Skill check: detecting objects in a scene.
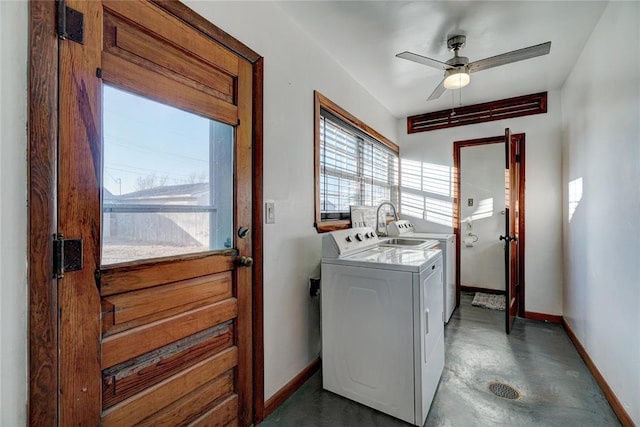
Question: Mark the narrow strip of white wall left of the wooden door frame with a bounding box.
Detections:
[0,1,27,426]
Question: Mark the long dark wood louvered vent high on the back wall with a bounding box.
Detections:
[407,92,547,133]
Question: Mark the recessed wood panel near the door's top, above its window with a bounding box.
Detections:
[104,14,235,103]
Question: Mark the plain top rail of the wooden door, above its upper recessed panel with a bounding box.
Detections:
[103,0,238,76]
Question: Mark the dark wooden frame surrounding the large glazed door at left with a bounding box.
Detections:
[27,0,264,426]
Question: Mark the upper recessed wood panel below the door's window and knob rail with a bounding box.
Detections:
[102,272,232,336]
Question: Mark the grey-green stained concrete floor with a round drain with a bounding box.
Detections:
[260,293,620,427]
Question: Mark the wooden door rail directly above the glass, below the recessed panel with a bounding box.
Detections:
[102,51,238,125]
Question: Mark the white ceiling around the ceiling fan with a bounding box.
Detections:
[278,0,607,118]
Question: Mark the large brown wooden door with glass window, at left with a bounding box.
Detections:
[57,0,253,425]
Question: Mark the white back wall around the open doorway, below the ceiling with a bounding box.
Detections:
[397,91,562,315]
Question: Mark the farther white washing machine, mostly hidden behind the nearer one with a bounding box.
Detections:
[387,219,457,323]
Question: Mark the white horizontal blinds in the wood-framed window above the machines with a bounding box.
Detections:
[319,109,398,220]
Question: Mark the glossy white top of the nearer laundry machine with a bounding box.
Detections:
[325,246,442,272]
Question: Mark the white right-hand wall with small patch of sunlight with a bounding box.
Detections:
[562,2,640,425]
